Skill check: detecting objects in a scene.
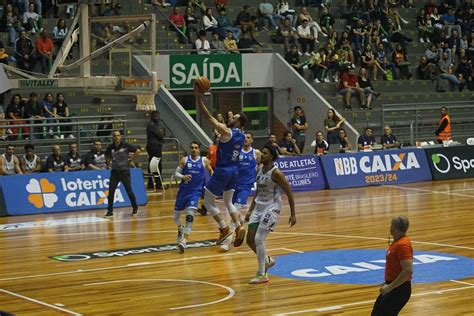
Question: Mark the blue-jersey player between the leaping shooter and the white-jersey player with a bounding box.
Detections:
[221,132,261,251]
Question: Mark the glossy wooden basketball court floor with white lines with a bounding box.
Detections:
[0,179,474,316]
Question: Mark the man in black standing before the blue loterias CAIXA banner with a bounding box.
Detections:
[104,131,140,218]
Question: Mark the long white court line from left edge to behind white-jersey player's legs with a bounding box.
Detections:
[0,248,282,281]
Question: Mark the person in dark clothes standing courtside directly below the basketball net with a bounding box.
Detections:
[146,111,166,189]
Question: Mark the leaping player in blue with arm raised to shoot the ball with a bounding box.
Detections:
[194,86,247,244]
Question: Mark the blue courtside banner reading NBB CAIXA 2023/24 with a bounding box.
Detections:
[321,148,431,189]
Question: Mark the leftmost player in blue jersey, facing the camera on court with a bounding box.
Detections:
[173,142,212,253]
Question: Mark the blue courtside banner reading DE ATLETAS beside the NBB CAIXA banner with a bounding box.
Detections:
[274,155,326,192]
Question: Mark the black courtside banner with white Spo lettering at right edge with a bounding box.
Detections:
[425,146,474,180]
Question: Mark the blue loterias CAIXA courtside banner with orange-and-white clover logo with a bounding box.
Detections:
[0,168,147,215]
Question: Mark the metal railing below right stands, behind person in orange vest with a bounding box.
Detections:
[382,101,474,144]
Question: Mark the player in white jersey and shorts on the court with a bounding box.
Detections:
[245,145,296,284]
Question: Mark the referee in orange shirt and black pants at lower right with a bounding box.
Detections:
[372,216,413,316]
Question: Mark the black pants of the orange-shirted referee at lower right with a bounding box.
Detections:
[372,281,411,316]
